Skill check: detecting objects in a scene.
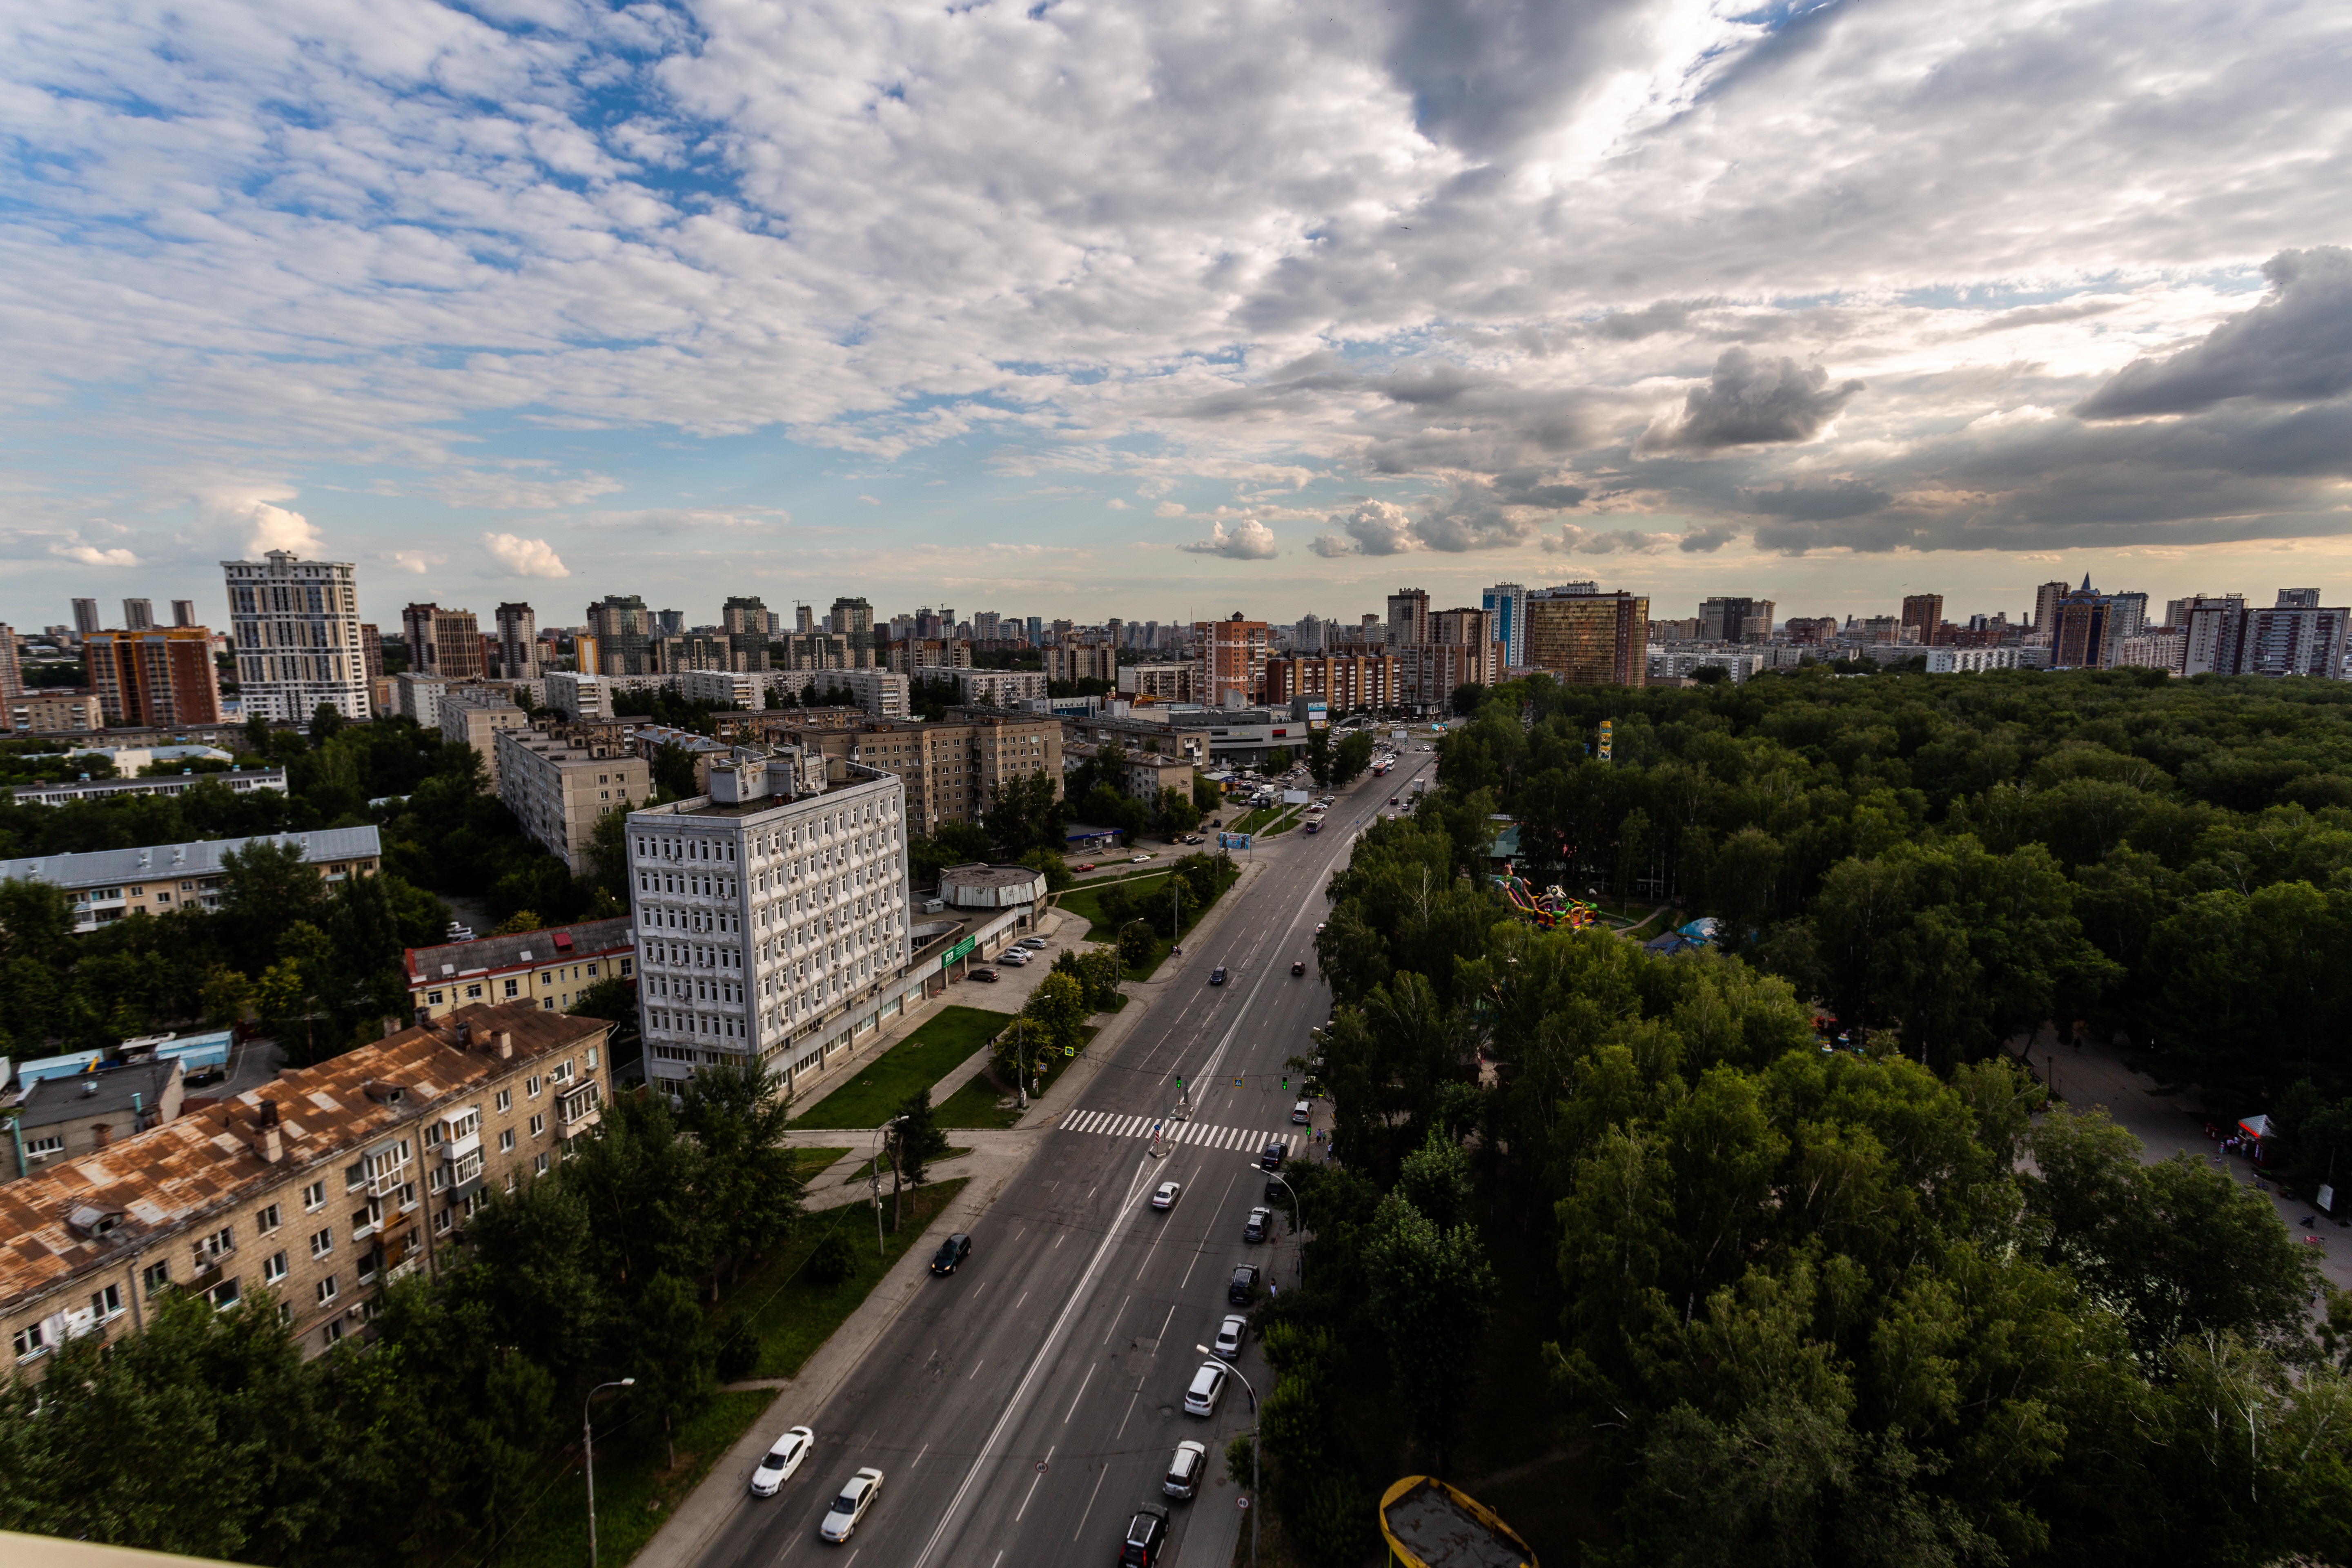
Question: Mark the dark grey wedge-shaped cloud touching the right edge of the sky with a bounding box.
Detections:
[2074,245,2352,419]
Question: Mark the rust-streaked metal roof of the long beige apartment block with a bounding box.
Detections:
[0,1002,612,1312]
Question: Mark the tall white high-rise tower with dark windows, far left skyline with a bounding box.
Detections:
[221,550,369,724]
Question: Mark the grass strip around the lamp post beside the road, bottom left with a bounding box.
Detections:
[492,1389,776,1568]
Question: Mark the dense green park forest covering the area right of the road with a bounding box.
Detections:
[1263,670,2352,1568]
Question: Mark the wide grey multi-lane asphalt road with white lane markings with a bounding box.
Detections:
[701,731,1435,1568]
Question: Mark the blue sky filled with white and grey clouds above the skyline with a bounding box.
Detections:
[0,0,2352,625]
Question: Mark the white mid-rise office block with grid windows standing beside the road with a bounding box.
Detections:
[628,748,922,1086]
